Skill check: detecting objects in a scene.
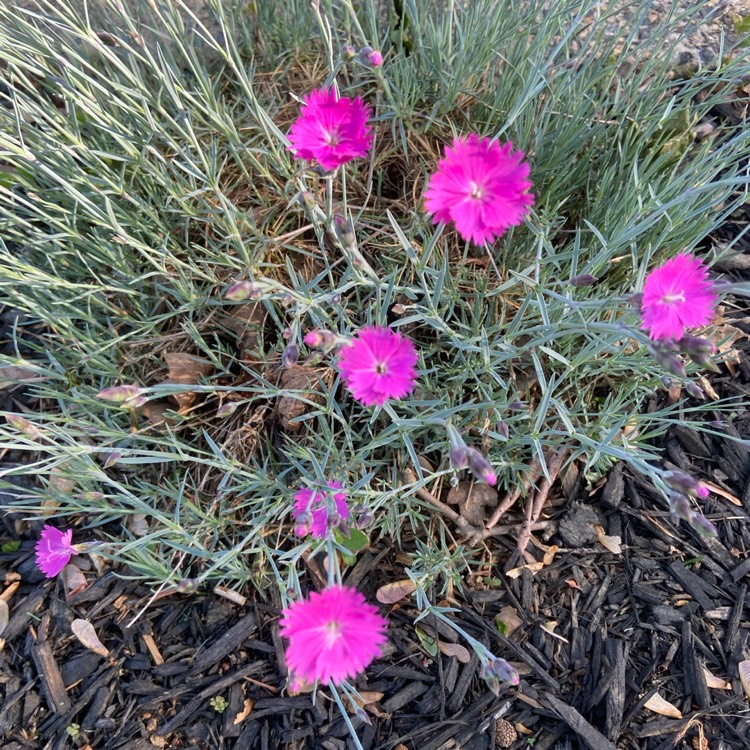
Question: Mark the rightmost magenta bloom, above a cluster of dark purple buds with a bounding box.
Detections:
[641,253,716,339]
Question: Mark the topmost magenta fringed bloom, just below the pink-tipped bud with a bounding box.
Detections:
[289,89,372,170]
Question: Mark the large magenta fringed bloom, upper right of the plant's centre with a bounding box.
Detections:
[425,134,534,245]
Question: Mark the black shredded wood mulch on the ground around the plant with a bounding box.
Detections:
[0,72,750,750]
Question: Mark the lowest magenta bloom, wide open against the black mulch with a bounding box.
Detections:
[280,586,387,685]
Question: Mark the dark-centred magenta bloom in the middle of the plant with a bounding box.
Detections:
[339,328,417,406]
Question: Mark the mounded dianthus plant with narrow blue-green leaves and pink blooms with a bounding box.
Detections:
[0,0,750,736]
